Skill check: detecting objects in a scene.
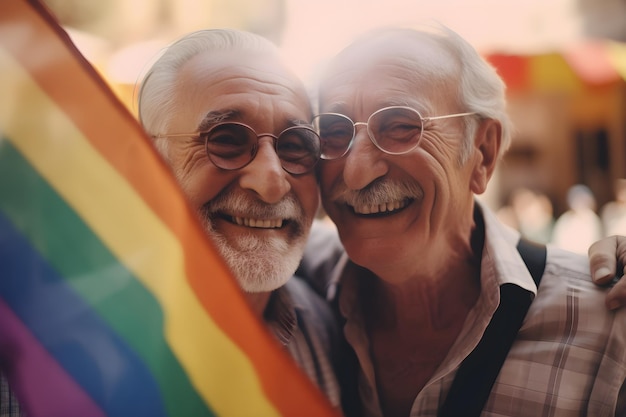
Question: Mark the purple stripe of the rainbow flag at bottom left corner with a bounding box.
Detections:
[0,298,105,417]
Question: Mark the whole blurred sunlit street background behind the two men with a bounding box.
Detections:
[44,0,626,251]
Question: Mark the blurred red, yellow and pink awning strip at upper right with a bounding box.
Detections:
[485,41,626,92]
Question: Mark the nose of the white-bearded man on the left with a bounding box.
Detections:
[239,137,291,204]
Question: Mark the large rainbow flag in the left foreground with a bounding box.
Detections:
[0,0,334,417]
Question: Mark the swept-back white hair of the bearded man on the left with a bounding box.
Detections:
[138,29,279,155]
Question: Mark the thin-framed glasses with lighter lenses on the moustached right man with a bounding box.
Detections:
[313,106,475,160]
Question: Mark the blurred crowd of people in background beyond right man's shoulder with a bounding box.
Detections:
[498,178,626,254]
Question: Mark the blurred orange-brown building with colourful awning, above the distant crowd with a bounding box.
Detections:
[487,46,626,215]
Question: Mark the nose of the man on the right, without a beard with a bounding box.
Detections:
[343,123,388,190]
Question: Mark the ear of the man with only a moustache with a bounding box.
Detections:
[470,119,502,194]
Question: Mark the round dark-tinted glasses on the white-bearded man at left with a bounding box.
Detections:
[155,122,321,175]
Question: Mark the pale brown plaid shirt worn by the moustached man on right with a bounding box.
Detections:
[334,203,626,417]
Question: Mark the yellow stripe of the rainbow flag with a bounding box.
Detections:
[0,44,279,416]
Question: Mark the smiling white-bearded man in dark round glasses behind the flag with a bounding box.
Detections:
[139,30,340,408]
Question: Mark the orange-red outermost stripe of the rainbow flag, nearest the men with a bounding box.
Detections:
[0,1,334,416]
